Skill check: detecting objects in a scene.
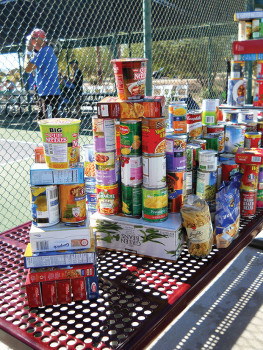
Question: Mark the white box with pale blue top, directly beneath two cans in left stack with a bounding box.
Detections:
[29,220,95,253]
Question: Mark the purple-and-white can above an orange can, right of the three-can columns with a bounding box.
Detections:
[166,134,187,171]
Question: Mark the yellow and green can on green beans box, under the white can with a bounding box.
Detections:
[142,187,168,222]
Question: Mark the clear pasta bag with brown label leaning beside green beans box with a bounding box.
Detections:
[181,195,213,258]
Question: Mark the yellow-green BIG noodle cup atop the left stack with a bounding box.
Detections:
[38,118,80,169]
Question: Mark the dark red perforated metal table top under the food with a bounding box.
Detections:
[0,210,263,350]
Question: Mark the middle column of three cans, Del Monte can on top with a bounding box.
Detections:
[120,120,142,216]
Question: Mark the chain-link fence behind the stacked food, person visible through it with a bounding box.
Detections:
[0,0,247,231]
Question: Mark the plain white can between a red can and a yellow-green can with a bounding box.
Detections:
[142,153,166,188]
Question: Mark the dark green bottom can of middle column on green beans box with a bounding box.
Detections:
[121,184,142,216]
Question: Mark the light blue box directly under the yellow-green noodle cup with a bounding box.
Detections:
[30,163,84,186]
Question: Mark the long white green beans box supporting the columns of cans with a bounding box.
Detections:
[90,213,184,261]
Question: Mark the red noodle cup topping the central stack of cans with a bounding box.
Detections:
[111,58,147,100]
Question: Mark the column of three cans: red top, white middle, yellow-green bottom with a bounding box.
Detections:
[142,118,168,222]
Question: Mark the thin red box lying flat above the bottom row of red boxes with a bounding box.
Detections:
[28,264,94,283]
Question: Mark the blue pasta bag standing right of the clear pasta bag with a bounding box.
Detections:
[215,173,242,248]
